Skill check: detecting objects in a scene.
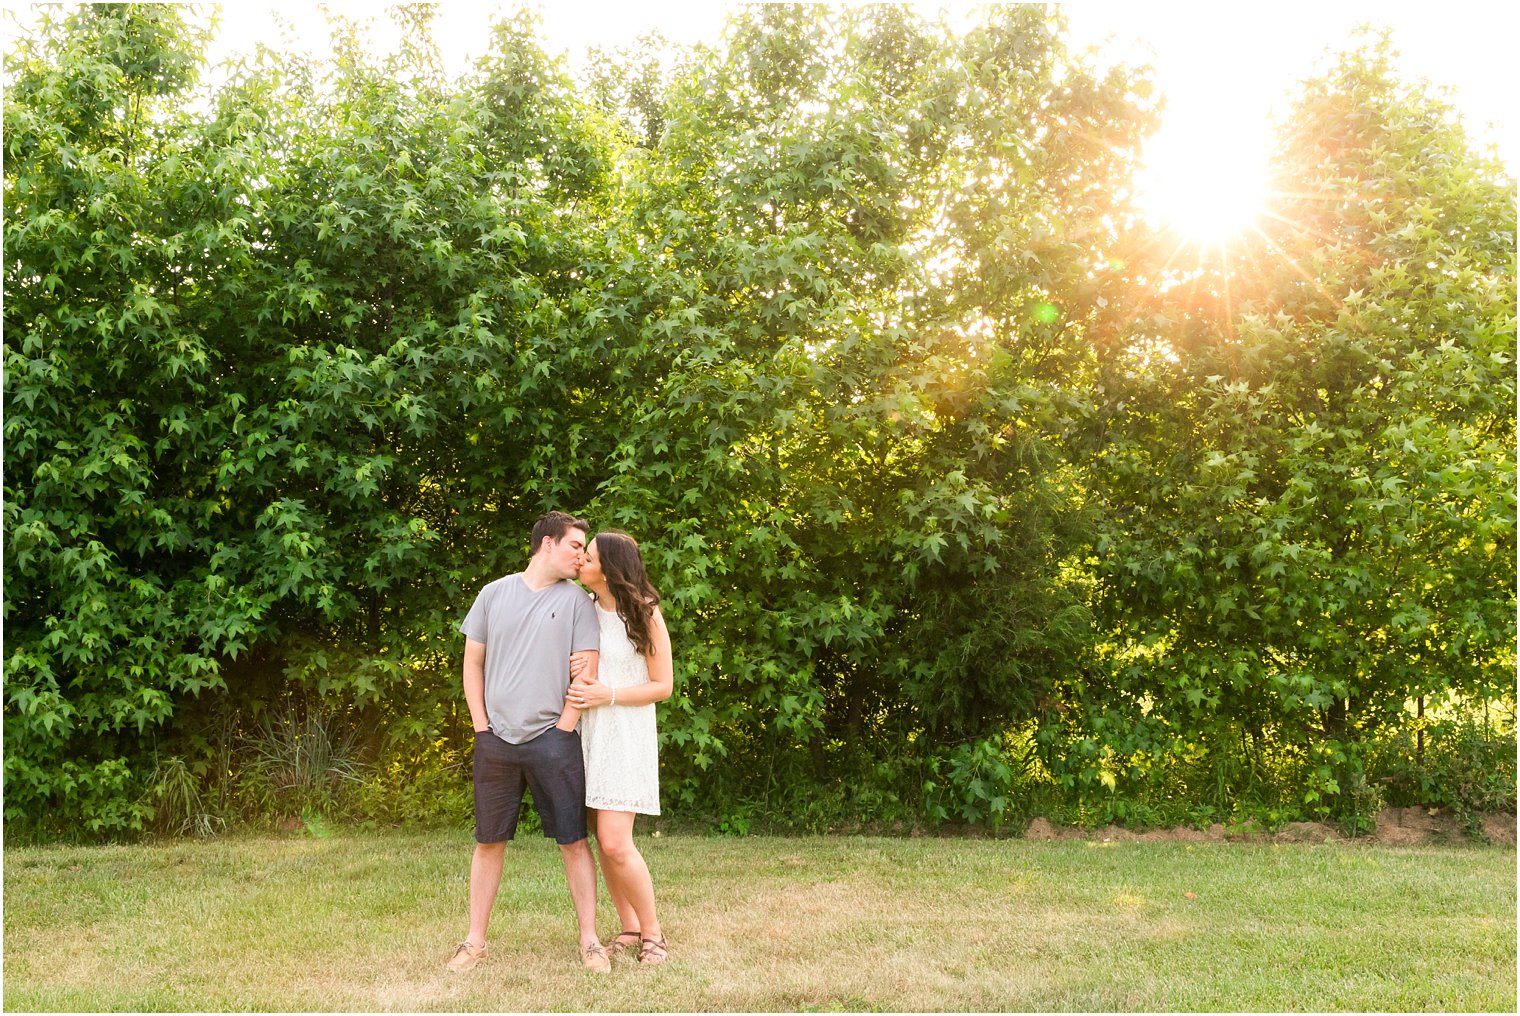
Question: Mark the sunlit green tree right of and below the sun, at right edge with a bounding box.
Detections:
[1096,40,1515,814]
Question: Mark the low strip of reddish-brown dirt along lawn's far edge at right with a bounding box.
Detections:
[1024,808,1515,847]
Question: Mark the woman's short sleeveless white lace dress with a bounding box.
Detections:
[581,605,660,815]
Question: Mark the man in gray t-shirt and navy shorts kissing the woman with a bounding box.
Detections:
[448,511,611,973]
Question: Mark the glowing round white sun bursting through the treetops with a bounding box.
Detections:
[1135,122,1266,246]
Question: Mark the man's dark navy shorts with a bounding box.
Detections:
[474,727,587,844]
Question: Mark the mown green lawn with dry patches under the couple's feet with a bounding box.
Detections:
[5,830,1515,1013]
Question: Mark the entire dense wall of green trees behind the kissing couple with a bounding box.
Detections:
[3,5,1515,837]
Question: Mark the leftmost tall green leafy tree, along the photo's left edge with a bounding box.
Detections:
[5,5,241,832]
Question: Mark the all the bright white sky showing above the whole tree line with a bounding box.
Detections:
[6,0,1520,238]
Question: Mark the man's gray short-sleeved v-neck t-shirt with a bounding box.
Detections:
[459,572,602,744]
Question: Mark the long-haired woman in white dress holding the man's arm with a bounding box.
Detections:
[567,531,673,966]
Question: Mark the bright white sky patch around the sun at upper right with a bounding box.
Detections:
[1064,0,1520,239]
